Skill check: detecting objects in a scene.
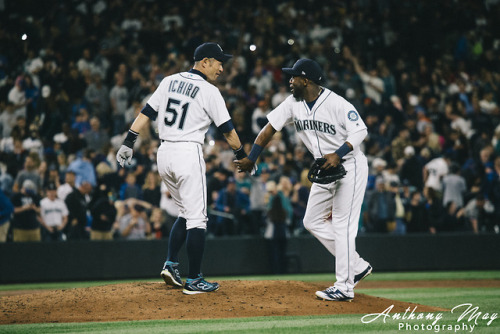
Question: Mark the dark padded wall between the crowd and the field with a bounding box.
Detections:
[0,234,500,283]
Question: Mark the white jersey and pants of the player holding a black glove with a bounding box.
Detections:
[267,88,369,297]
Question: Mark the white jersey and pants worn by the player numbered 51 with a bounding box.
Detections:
[148,72,231,230]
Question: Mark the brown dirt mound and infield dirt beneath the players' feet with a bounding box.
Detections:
[0,280,500,324]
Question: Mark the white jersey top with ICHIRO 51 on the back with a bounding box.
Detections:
[148,72,230,144]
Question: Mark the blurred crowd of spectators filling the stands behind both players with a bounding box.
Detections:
[0,0,500,242]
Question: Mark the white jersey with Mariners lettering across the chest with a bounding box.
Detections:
[267,88,366,159]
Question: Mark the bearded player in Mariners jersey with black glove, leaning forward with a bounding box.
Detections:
[236,59,372,301]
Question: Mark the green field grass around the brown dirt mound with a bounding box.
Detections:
[0,271,500,334]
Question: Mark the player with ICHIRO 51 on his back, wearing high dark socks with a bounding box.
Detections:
[116,43,250,294]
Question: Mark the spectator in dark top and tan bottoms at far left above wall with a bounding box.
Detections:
[12,179,42,242]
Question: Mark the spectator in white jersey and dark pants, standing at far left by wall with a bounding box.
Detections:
[40,183,68,241]
